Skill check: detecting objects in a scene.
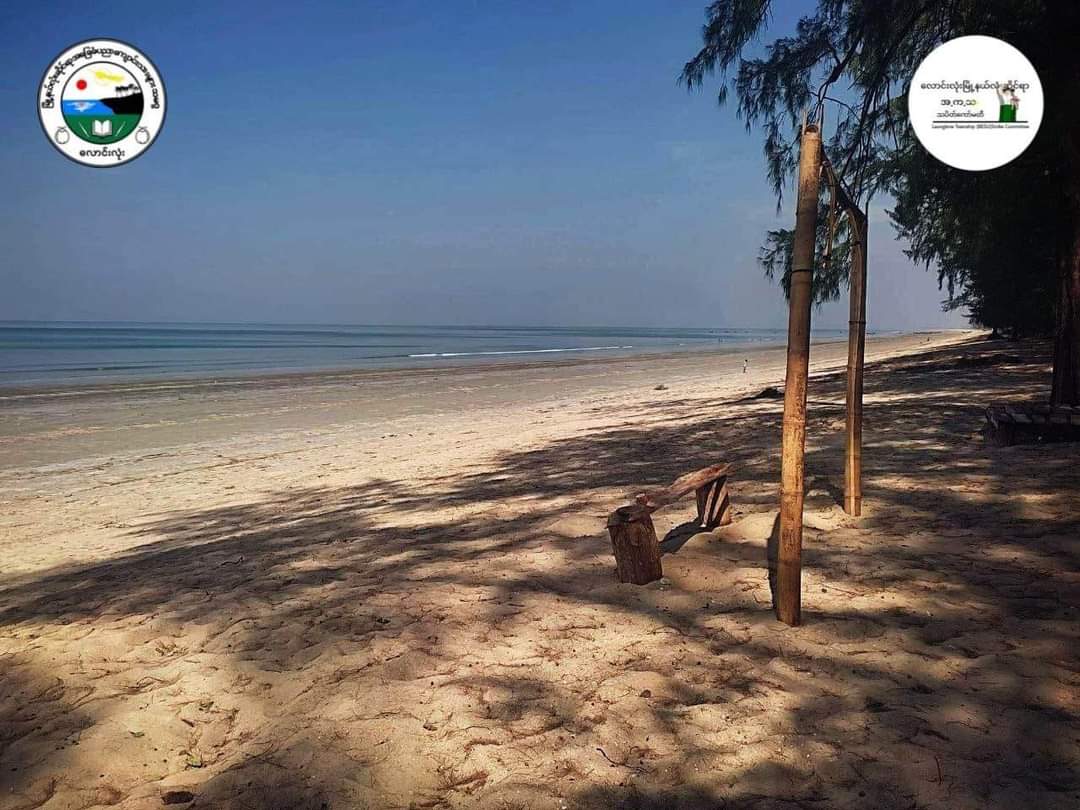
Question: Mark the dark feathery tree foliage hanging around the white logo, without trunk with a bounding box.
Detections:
[680,0,1080,332]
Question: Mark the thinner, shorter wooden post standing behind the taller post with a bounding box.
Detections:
[843,210,868,515]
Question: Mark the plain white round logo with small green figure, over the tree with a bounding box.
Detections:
[907,37,1042,172]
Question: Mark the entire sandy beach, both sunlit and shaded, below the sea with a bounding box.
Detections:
[0,333,1080,810]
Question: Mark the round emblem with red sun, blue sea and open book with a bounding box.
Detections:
[38,39,165,168]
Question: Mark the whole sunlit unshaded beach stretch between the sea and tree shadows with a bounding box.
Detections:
[0,332,978,567]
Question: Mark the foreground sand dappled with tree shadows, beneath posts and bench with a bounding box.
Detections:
[0,336,1080,810]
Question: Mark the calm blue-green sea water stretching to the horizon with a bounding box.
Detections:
[0,322,842,387]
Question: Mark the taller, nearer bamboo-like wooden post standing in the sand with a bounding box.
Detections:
[777,124,821,625]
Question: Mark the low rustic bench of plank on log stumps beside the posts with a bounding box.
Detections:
[607,464,731,585]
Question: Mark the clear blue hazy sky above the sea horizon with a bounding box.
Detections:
[0,0,963,329]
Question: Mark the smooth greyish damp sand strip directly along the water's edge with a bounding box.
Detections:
[0,333,977,475]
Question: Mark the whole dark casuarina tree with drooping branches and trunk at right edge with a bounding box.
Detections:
[680,0,1080,404]
